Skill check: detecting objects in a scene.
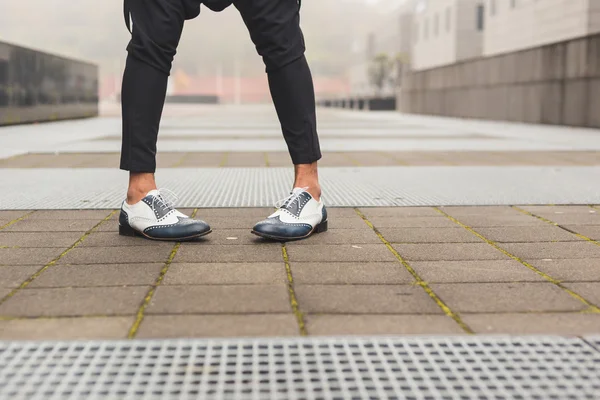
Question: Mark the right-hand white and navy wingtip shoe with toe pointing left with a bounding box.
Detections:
[252,188,327,242]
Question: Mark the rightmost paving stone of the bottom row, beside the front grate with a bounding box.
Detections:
[462,313,600,335]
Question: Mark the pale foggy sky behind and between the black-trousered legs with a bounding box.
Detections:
[0,0,398,75]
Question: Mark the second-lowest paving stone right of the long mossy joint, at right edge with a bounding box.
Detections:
[525,258,600,282]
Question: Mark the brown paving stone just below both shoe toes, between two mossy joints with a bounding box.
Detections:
[174,243,283,263]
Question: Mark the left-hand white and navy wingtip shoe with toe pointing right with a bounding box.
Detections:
[119,190,212,242]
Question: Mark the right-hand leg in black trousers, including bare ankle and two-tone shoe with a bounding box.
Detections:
[234,0,327,240]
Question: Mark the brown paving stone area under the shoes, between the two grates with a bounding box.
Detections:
[0,206,600,339]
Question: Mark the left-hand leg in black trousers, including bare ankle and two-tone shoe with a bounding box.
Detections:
[119,0,210,240]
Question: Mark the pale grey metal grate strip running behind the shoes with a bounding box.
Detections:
[0,167,600,210]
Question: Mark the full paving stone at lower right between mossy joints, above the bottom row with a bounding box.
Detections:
[430,282,587,313]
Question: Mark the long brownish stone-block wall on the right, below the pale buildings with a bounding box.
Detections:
[398,35,600,127]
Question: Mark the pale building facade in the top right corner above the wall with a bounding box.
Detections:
[483,0,600,56]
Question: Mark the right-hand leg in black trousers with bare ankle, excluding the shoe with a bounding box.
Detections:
[234,0,321,199]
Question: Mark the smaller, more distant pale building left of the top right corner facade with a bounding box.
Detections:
[411,0,486,71]
